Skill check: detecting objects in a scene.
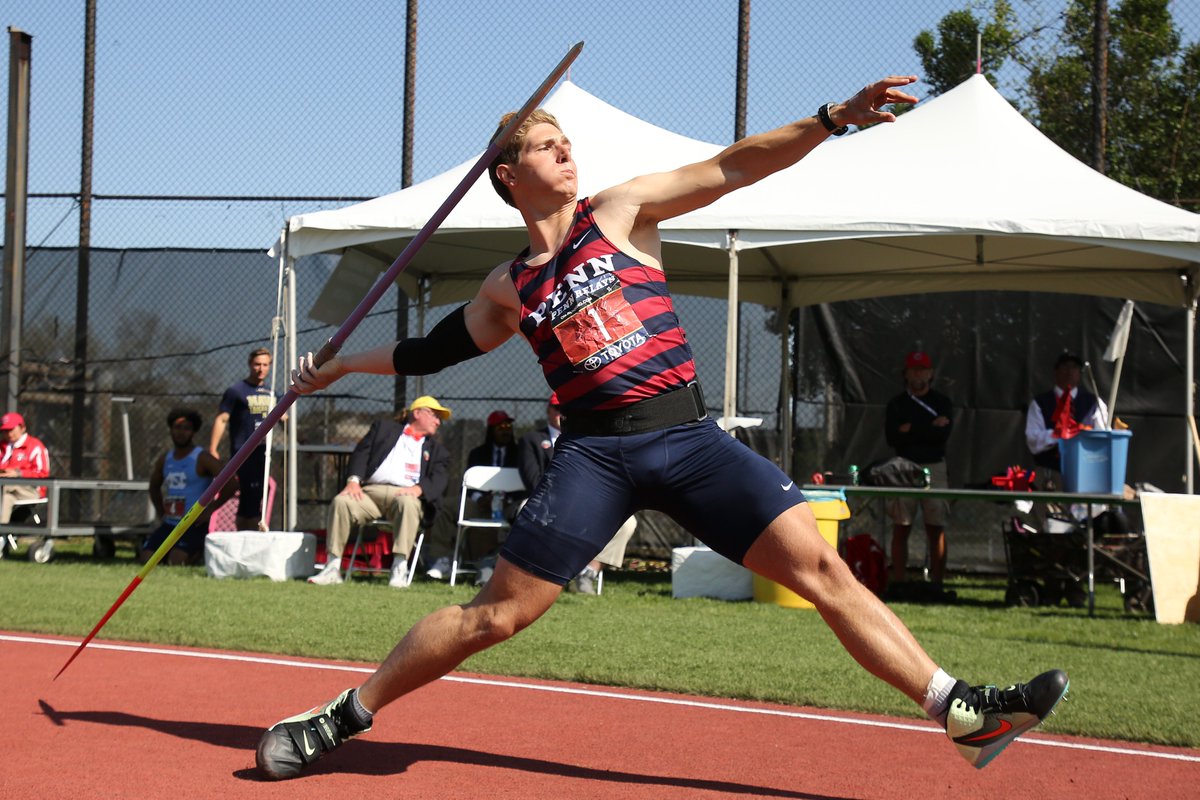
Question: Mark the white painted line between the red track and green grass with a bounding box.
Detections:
[7,633,1200,763]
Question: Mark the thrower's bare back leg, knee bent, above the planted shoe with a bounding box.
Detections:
[359,558,563,712]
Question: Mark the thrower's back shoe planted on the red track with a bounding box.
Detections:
[254,688,371,781]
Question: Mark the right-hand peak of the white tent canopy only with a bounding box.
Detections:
[668,74,1200,306]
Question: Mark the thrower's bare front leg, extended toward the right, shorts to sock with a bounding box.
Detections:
[743,504,937,705]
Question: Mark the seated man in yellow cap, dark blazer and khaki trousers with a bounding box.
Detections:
[308,395,450,589]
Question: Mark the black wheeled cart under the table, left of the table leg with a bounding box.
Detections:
[1002,517,1087,608]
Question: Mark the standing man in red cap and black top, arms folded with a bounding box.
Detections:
[883,350,953,600]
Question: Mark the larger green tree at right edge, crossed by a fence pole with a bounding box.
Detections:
[1028,0,1200,211]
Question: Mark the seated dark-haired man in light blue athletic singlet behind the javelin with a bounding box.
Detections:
[138,408,238,565]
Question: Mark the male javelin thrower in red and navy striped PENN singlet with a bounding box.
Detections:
[257,76,1068,778]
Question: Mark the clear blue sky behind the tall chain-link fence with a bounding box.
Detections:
[0,0,1200,247]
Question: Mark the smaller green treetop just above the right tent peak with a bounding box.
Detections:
[912,0,1018,95]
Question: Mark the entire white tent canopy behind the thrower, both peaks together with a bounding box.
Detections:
[278,74,1200,314]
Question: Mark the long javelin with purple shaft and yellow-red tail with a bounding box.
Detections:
[54,42,583,680]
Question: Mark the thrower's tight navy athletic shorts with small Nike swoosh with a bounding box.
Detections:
[500,419,804,585]
